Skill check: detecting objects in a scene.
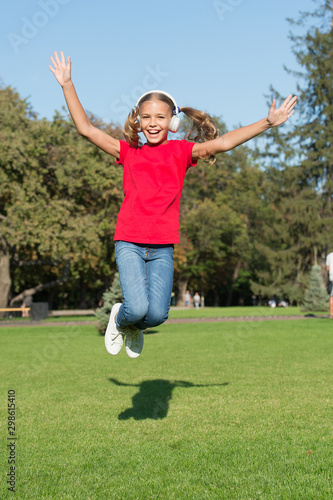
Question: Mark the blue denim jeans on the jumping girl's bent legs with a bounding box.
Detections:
[115,241,174,330]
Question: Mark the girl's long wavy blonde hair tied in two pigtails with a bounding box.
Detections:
[123,92,220,165]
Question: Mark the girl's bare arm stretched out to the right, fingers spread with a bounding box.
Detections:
[192,95,297,159]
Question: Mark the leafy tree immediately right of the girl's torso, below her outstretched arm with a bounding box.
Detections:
[174,118,263,305]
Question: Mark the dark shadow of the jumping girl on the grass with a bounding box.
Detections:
[109,378,229,420]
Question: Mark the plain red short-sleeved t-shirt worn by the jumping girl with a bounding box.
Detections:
[114,140,196,244]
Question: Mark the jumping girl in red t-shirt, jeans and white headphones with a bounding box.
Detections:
[49,52,297,358]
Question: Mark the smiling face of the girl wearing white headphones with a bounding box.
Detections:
[140,100,172,146]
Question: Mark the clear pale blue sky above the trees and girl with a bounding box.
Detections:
[0,0,315,129]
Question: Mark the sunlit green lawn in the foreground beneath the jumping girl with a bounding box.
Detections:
[0,318,333,500]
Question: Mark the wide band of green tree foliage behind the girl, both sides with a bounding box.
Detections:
[0,0,333,308]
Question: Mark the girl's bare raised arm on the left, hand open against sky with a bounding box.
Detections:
[49,52,120,158]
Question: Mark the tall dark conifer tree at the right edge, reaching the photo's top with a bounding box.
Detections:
[253,0,333,303]
